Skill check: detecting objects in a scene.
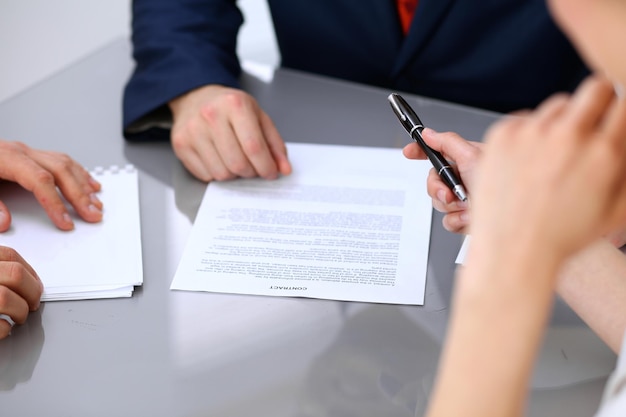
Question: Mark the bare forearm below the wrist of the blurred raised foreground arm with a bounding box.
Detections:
[428,245,557,417]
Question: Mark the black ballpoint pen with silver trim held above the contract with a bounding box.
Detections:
[387,93,467,201]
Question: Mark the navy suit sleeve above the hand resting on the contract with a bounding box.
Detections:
[123,0,243,140]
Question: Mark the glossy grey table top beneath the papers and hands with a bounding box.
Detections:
[0,40,615,417]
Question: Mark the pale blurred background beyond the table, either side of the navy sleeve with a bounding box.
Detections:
[0,0,279,102]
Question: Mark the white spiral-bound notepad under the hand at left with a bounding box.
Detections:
[0,165,143,301]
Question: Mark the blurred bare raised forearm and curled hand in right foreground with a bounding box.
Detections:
[428,78,626,417]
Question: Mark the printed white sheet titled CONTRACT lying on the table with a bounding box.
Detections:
[171,143,432,304]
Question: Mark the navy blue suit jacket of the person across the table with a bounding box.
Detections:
[123,0,588,139]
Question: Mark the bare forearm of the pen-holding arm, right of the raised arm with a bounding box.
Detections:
[557,240,626,353]
